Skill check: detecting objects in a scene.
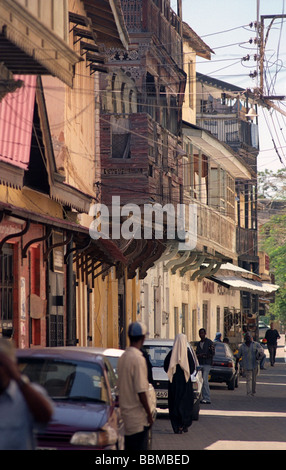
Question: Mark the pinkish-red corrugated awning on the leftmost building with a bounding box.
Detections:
[0,75,37,170]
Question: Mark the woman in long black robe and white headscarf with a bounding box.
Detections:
[164,334,196,434]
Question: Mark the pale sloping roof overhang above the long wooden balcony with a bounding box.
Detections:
[183,122,251,179]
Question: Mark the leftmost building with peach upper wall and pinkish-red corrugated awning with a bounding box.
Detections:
[0,0,128,347]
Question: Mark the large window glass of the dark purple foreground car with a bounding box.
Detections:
[19,358,109,403]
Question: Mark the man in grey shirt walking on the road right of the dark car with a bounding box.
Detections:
[236,332,264,396]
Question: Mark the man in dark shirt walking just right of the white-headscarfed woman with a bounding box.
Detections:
[196,328,215,404]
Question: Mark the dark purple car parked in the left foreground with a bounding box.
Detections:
[17,347,124,450]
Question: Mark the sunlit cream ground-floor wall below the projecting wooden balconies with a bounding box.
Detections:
[141,262,240,342]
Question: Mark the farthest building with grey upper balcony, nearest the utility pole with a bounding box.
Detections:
[194,73,275,340]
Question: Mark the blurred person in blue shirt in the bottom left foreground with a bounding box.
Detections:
[0,337,53,450]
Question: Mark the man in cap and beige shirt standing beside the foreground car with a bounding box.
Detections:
[118,322,153,451]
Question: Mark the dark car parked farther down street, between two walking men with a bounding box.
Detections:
[209,343,240,390]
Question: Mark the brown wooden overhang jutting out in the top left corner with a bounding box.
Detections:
[0,0,82,86]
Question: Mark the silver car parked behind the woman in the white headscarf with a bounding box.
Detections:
[143,339,203,421]
